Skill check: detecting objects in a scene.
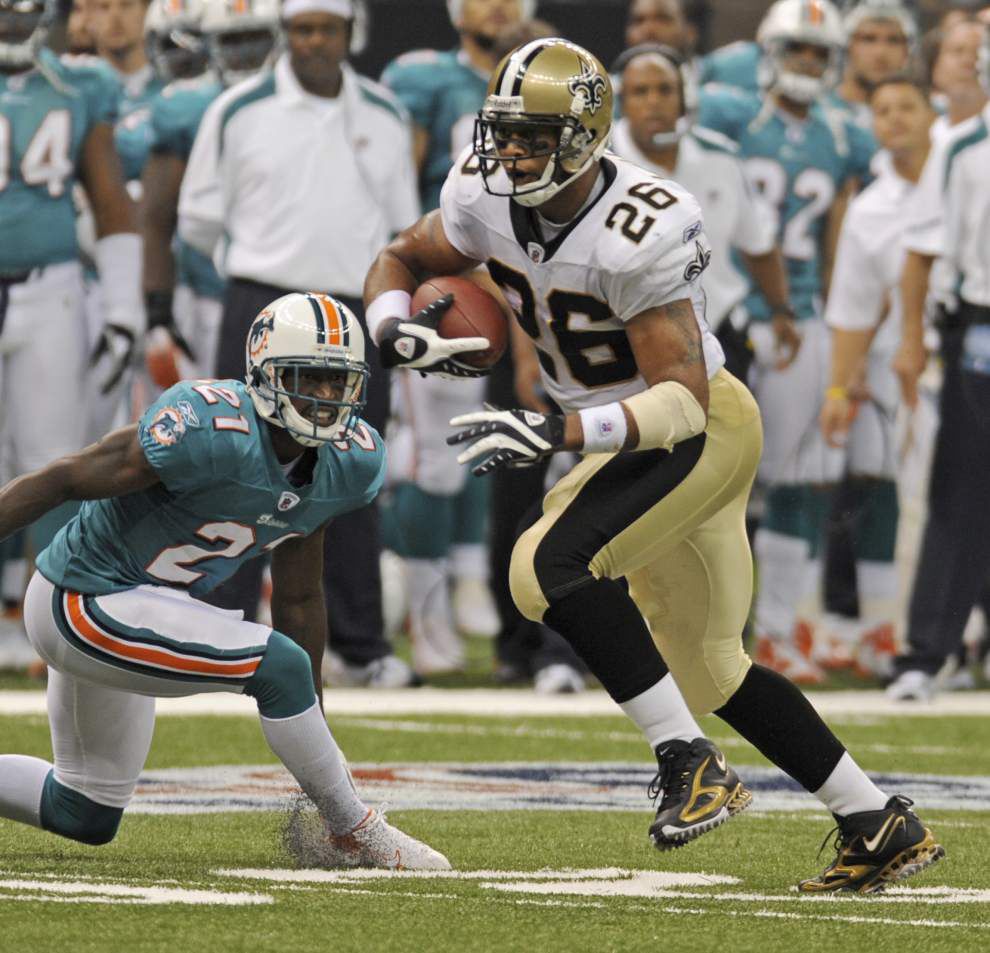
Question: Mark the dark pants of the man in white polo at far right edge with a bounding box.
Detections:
[897,303,990,675]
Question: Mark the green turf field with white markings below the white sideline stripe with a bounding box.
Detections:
[0,696,990,953]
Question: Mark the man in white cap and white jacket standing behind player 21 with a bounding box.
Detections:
[179,0,419,686]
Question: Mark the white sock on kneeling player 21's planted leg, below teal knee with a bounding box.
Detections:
[261,702,368,834]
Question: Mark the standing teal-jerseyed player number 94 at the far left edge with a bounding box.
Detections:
[0,0,143,665]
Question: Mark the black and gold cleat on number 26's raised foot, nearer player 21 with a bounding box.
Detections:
[648,738,753,850]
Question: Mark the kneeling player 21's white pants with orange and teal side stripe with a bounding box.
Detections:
[24,573,272,808]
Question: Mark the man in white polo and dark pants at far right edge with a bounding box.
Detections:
[891,27,990,697]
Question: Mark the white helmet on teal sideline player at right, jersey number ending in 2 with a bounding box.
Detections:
[756,0,845,103]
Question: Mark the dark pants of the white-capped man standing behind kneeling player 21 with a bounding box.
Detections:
[206,278,391,665]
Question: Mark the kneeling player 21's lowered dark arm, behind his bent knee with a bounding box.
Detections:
[272,528,327,704]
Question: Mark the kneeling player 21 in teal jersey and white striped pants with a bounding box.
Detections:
[0,294,450,869]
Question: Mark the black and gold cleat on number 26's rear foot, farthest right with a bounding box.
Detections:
[798,794,945,893]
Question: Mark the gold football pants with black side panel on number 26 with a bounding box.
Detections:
[509,370,762,714]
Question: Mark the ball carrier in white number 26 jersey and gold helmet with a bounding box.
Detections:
[365,39,941,892]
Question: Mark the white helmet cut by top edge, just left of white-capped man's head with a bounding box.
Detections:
[202,0,282,86]
